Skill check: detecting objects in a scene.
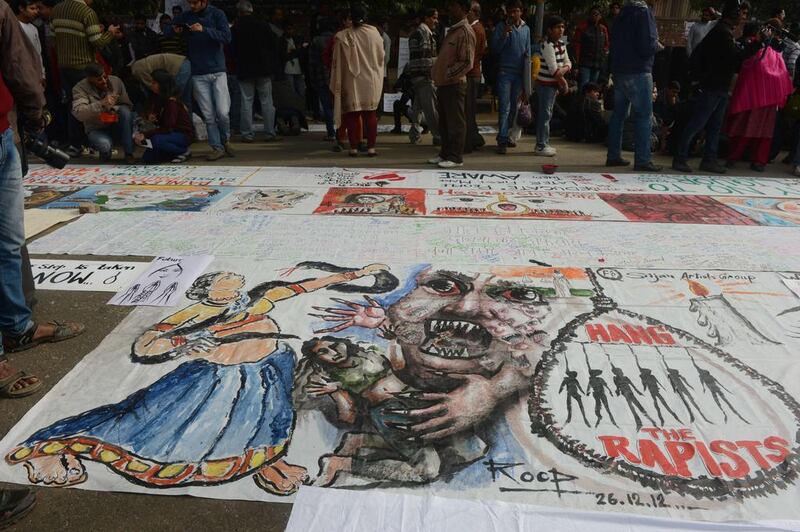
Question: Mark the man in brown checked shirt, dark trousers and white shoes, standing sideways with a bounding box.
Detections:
[428,0,475,168]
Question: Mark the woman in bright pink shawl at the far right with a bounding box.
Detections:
[725,28,794,172]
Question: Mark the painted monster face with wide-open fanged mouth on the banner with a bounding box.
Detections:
[389,268,591,375]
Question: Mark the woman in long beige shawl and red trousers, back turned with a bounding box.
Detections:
[330,4,385,157]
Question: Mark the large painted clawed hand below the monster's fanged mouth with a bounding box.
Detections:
[387,375,498,441]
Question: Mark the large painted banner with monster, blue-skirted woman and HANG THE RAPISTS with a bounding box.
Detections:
[0,260,800,521]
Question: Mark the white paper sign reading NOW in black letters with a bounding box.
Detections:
[31,259,148,292]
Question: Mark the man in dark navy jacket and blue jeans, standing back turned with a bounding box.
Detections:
[606,0,661,172]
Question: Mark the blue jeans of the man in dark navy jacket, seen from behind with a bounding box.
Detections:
[608,74,653,166]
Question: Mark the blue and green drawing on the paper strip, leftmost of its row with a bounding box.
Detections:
[44,185,231,212]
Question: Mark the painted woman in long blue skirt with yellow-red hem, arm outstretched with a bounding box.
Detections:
[6,264,388,495]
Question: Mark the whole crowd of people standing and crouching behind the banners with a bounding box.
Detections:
[3,0,800,171]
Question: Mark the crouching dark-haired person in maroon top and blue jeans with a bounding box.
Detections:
[133,69,194,164]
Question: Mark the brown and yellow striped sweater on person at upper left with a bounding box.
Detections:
[53,0,113,69]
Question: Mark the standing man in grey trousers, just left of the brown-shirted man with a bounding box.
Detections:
[405,8,442,146]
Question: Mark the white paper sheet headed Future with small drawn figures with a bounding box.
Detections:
[108,255,214,307]
